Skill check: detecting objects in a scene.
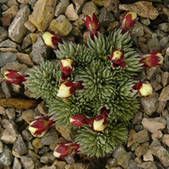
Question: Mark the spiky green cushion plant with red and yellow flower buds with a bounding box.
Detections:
[25,12,162,158]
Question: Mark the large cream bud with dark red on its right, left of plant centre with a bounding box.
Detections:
[57,81,76,98]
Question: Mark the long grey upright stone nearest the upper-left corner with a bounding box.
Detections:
[8,5,30,43]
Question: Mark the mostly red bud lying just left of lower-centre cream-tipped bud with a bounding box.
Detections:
[70,114,88,127]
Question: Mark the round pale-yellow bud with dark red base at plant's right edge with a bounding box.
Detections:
[136,82,153,96]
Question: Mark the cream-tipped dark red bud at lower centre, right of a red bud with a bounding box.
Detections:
[92,112,108,131]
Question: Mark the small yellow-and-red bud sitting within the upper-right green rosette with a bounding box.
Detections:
[110,49,126,67]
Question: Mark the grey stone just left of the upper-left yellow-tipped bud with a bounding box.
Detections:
[31,37,47,64]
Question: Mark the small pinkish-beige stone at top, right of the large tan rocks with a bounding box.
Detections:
[65,4,79,21]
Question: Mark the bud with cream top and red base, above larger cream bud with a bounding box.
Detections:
[60,59,73,76]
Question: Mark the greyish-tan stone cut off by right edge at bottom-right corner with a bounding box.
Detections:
[151,146,169,167]
